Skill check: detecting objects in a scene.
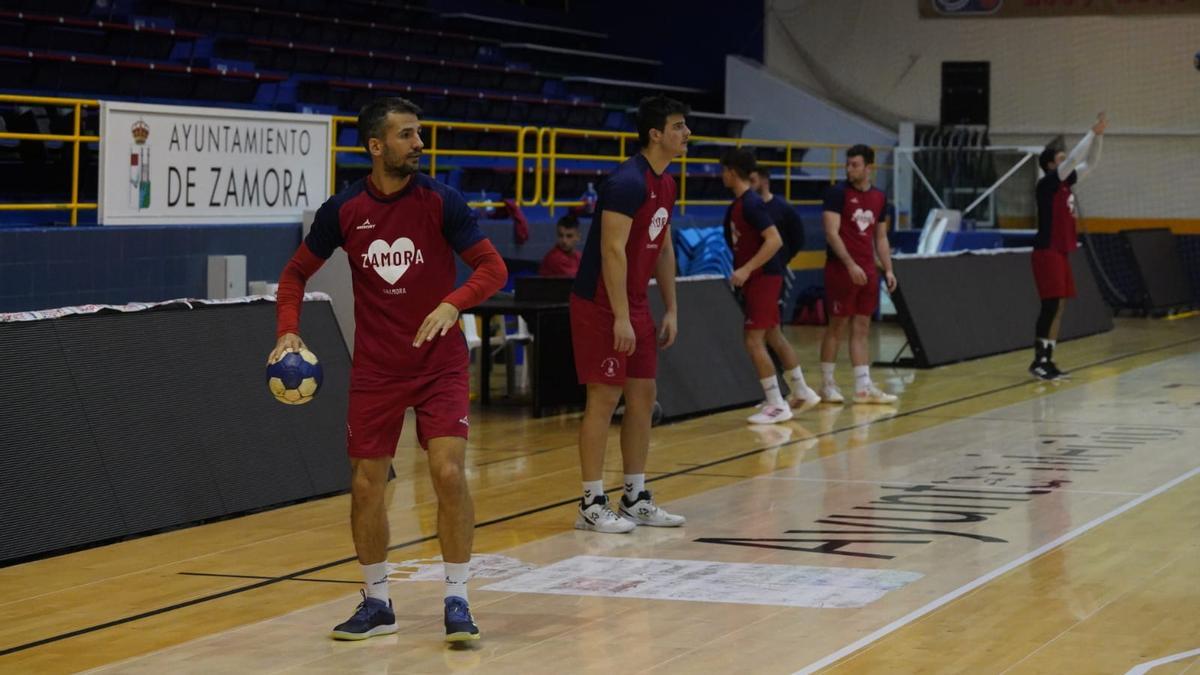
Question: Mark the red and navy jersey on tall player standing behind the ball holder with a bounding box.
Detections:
[574,153,676,311]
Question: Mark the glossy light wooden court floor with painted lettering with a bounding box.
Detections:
[0,318,1200,675]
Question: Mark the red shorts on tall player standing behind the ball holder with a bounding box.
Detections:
[571,293,659,386]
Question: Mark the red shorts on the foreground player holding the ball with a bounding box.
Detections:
[346,365,470,458]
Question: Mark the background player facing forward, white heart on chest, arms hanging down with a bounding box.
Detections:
[821,144,896,404]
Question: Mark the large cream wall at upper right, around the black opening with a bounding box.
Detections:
[764,0,1200,219]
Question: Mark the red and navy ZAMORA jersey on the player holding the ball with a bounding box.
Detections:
[305,174,484,376]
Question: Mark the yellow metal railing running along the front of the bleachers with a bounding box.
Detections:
[0,95,892,225]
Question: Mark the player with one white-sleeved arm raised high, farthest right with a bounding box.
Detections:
[1030,113,1109,380]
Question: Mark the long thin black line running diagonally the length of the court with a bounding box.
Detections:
[0,338,1200,656]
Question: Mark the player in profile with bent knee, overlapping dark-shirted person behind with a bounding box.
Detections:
[721,148,817,424]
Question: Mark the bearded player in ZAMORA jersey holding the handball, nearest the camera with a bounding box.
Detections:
[270,98,508,641]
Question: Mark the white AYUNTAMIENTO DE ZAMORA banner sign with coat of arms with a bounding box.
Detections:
[100,101,331,225]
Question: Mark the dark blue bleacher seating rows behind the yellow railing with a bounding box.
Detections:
[0,0,748,225]
